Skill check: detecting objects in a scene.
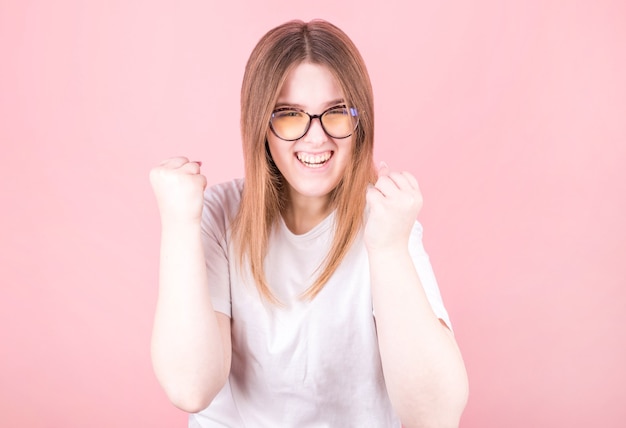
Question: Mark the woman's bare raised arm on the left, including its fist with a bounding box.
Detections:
[150,158,231,412]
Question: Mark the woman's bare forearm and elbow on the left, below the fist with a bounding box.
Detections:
[152,224,230,412]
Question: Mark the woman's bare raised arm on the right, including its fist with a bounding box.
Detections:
[365,162,468,428]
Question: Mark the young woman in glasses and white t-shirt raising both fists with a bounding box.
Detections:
[151,20,467,428]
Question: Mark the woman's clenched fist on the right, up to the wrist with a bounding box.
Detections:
[365,162,423,251]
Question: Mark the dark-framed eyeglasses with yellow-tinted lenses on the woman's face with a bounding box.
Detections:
[270,106,359,141]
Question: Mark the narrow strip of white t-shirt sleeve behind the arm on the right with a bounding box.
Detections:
[409,221,452,329]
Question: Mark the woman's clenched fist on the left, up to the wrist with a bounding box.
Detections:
[150,157,207,224]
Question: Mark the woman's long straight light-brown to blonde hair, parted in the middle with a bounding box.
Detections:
[233,20,376,304]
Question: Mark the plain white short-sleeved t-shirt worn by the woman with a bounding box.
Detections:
[189,180,450,428]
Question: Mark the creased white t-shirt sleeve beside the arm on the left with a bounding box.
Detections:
[202,181,236,317]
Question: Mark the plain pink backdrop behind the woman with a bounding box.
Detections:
[0,0,626,428]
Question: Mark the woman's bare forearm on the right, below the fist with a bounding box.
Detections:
[369,248,468,428]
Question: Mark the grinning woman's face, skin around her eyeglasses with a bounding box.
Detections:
[267,63,354,209]
